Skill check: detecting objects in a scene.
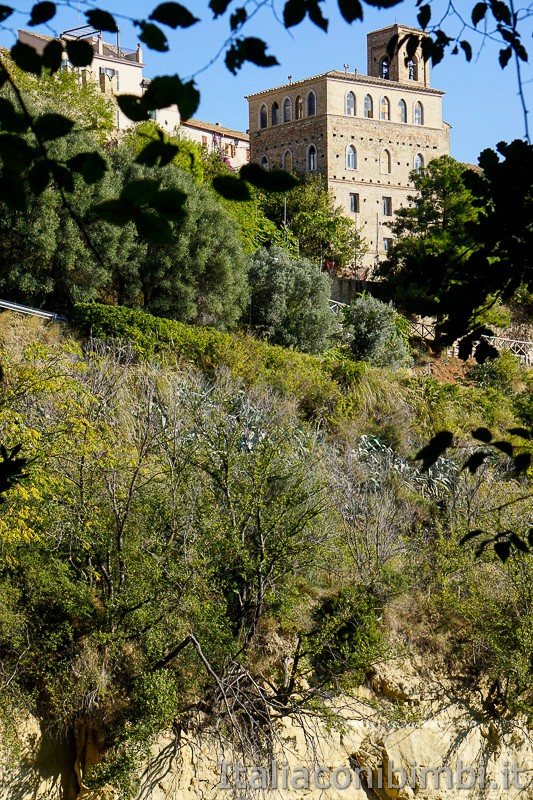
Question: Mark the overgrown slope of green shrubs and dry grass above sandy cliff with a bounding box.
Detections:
[0,305,533,797]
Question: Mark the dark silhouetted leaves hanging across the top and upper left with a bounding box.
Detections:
[0,0,527,276]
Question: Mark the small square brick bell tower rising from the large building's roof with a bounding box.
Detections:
[366,25,430,88]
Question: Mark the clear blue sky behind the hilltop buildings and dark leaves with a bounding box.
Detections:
[0,0,533,163]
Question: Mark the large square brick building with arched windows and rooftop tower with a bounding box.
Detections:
[247,25,450,278]
